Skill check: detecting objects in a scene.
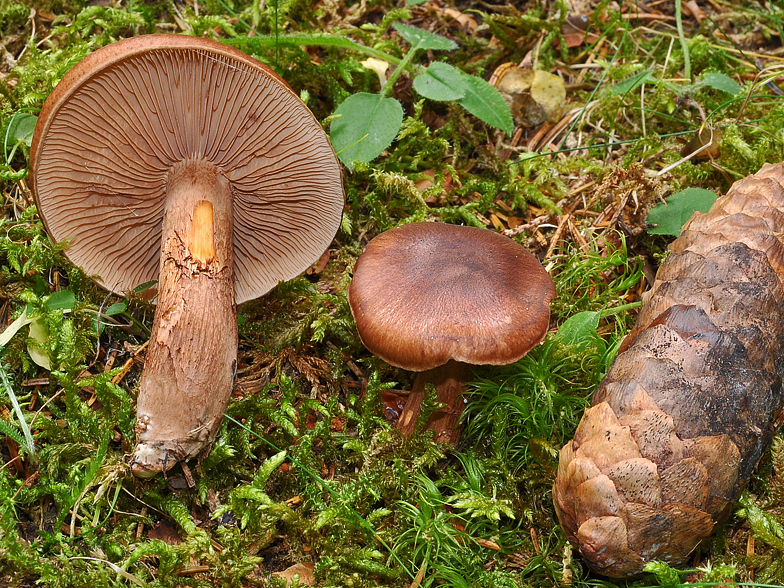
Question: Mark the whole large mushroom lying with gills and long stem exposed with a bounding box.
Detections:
[30,35,343,477]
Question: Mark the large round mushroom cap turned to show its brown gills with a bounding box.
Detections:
[30,35,343,303]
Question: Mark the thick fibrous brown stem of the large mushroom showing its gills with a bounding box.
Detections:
[132,160,238,477]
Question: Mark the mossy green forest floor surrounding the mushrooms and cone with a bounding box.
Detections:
[0,0,784,588]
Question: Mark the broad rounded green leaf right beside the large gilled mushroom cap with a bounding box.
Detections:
[329,92,403,169]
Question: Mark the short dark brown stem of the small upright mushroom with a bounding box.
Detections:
[397,359,473,445]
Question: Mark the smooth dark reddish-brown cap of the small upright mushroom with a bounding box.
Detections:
[348,223,555,371]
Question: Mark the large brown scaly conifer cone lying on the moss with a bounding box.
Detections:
[553,164,784,577]
